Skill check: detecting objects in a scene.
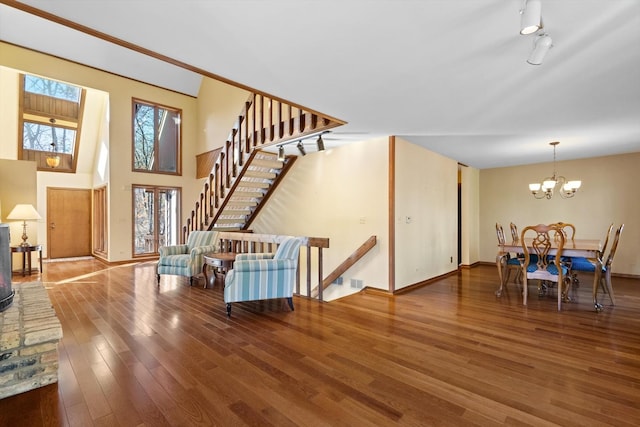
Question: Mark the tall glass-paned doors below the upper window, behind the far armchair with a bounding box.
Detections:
[132,185,180,256]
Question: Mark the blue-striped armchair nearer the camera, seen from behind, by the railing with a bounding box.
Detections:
[224,237,302,316]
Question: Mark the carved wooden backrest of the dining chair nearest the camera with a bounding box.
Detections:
[520,224,565,271]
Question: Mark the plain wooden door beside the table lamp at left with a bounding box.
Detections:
[47,187,91,259]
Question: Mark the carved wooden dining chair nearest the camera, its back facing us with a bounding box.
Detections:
[520,224,568,311]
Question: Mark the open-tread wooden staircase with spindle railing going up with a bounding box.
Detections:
[182,93,345,242]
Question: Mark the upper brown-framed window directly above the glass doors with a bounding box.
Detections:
[133,99,182,175]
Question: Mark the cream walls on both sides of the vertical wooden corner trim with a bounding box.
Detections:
[251,138,457,300]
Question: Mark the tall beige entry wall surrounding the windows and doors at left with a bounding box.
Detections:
[0,43,201,261]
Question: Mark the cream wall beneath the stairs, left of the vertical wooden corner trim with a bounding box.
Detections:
[251,138,389,299]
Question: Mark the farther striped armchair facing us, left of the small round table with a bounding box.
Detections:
[156,231,218,285]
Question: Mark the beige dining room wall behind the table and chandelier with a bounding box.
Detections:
[480,153,640,275]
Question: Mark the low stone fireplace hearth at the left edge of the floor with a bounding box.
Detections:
[0,282,62,399]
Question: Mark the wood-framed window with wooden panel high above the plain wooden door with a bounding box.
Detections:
[18,74,84,172]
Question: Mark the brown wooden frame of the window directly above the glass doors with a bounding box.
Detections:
[131,98,182,176]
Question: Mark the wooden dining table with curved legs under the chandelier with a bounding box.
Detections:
[496,238,602,311]
